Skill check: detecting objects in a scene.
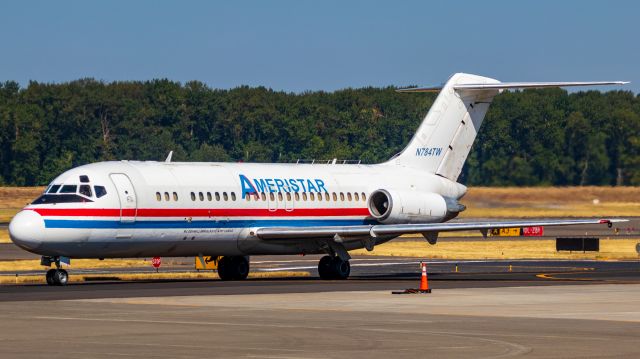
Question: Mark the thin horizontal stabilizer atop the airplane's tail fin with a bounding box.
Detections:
[396,81,629,92]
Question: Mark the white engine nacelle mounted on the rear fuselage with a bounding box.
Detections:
[367,189,465,224]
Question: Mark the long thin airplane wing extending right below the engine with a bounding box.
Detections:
[255,219,628,240]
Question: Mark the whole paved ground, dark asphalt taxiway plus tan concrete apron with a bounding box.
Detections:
[0,256,640,358]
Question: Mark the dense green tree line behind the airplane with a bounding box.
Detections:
[0,79,640,186]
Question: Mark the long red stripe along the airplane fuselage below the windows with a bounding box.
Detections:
[32,208,369,217]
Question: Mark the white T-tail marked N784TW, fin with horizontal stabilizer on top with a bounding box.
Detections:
[388,73,628,181]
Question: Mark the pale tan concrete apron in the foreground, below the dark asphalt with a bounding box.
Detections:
[0,284,640,358]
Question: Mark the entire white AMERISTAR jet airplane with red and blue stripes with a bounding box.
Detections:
[9,73,626,285]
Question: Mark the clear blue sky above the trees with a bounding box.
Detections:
[0,0,640,93]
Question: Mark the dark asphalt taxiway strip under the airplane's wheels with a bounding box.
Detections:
[0,256,640,302]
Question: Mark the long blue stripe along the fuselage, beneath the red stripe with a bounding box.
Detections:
[44,219,374,229]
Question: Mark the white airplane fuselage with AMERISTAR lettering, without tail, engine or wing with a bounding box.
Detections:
[12,161,466,258]
